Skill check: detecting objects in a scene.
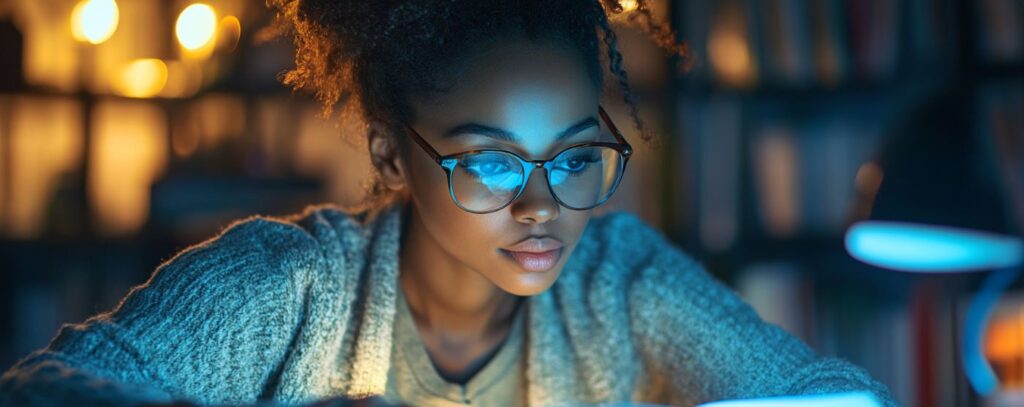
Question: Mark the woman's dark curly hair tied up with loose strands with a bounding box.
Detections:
[266,0,687,210]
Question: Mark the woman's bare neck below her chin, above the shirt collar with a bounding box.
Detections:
[398,205,519,340]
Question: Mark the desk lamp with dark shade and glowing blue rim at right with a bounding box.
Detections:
[845,90,1024,396]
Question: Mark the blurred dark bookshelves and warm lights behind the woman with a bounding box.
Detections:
[0,0,1024,406]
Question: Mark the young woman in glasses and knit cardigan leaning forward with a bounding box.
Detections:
[0,0,895,405]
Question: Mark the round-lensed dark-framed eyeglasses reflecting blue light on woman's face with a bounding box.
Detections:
[406,106,633,213]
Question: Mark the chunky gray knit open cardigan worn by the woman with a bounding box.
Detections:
[0,205,896,406]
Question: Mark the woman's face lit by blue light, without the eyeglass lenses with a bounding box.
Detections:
[393,41,611,295]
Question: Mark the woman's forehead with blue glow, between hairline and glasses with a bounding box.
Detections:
[413,40,599,154]
